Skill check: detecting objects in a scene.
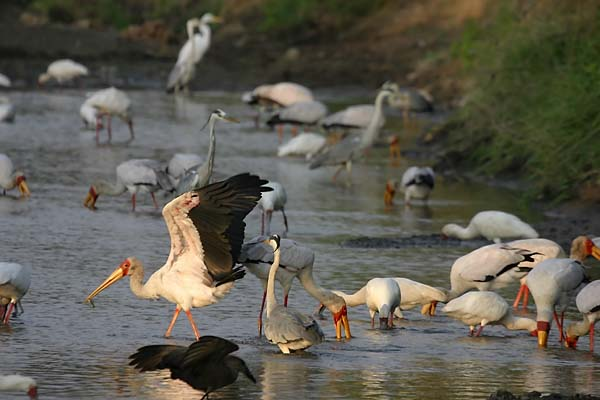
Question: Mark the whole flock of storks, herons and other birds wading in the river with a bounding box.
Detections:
[0,14,600,398]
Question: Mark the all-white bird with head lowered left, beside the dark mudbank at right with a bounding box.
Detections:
[442,211,539,243]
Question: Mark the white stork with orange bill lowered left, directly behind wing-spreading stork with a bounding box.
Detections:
[83,158,173,211]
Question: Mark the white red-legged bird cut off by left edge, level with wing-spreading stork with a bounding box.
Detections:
[0,262,31,324]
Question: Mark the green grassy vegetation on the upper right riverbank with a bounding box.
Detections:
[448,2,600,201]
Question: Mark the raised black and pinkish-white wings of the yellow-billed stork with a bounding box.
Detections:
[163,173,271,278]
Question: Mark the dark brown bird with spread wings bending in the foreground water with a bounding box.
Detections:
[129,336,256,399]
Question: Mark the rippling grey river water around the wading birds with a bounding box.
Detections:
[0,90,600,400]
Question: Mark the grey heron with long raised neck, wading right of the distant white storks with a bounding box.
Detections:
[309,87,395,182]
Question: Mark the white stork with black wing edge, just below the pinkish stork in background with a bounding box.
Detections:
[267,100,327,143]
